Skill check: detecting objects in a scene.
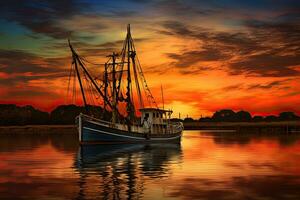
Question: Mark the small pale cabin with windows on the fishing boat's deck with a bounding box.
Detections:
[140,108,172,134]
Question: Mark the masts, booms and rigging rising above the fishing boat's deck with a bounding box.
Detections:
[69,24,159,124]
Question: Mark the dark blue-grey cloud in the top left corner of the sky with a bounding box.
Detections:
[0,0,88,39]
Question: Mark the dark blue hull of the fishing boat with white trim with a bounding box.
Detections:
[78,116,182,143]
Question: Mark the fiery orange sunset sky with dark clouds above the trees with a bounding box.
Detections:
[0,0,300,118]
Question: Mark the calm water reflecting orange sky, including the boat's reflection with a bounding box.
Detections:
[0,131,300,200]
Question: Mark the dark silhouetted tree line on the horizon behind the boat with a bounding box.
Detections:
[0,104,300,126]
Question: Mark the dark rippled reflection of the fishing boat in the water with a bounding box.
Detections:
[75,144,182,199]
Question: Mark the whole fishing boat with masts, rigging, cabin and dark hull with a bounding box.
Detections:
[69,25,183,143]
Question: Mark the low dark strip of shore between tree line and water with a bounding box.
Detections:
[0,121,300,134]
